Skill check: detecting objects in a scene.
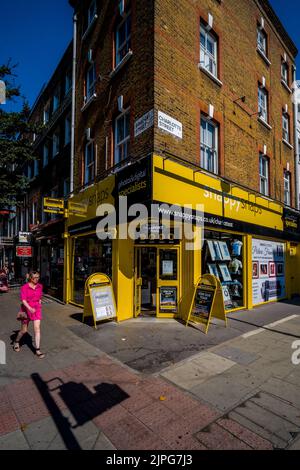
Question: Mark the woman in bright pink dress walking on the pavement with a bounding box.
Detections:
[13,271,45,359]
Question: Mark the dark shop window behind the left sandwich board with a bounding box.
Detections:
[72,239,112,305]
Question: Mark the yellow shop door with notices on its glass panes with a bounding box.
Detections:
[156,247,180,317]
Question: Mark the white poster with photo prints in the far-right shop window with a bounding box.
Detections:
[252,239,286,305]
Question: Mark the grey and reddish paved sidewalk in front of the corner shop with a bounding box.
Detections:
[0,291,300,451]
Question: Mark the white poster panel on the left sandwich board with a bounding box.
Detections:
[90,286,117,321]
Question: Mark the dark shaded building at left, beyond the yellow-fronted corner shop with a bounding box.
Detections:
[10,43,73,299]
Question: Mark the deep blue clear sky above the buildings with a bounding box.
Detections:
[0,0,300,110]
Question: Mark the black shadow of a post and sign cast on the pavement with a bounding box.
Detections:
[31,374,129,450]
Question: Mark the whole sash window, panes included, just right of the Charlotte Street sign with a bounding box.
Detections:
[201,118,218,174]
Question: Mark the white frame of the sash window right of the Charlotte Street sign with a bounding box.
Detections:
[200,116,219,175]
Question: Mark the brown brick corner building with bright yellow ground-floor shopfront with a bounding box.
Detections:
[65,0,300,319]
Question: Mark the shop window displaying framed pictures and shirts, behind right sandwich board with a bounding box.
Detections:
[202,230,245,310]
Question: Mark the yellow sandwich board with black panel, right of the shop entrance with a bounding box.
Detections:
[186,274,227,334]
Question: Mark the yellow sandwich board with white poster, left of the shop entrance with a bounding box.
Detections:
[82,274,117,329]
